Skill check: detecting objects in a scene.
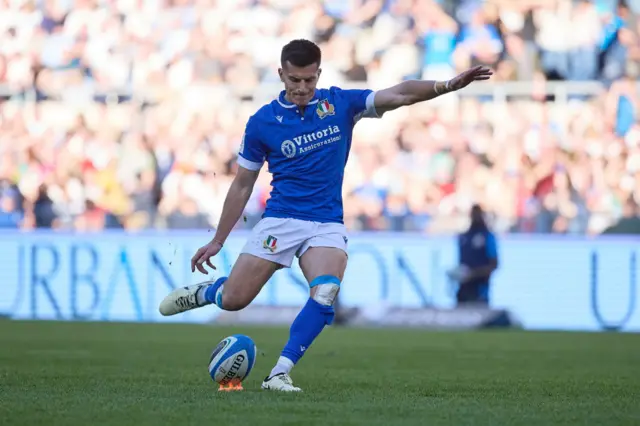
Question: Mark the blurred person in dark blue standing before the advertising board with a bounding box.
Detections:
[449,204,498,306]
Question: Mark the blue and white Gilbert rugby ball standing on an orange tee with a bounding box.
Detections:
[209,334,257,385]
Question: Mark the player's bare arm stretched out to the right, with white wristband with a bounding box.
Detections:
[374,66,493,116]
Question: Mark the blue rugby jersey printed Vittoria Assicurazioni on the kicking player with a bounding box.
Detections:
[238,87,379,223]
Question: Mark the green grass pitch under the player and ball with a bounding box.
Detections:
[0,321,640,426]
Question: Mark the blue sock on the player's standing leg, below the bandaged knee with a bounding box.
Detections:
[281,298,334,364]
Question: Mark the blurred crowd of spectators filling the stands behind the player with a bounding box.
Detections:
[0,0,640,234]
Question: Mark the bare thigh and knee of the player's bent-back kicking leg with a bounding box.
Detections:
[222,253,282,311]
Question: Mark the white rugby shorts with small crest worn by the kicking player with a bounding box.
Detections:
[242,217,348,268]
